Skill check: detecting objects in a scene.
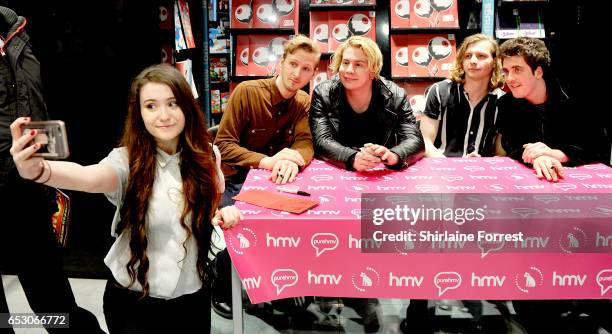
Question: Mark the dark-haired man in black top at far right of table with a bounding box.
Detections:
[497,37,606,181]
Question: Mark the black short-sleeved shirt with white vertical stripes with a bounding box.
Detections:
[423,79,503,157]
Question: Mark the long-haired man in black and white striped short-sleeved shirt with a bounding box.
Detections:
[420,34,503,157]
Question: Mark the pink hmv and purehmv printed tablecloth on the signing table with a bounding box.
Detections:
[225,158,612,303]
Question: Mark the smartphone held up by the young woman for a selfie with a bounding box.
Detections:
[23,121,70,159]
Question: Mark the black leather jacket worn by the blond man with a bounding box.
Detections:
[310,75,425,169]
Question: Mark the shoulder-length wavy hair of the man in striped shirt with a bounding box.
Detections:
[449,34,504,90]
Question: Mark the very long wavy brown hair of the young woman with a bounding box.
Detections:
[117,65,220,296]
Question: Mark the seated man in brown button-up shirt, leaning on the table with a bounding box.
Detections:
[215,35,321,206]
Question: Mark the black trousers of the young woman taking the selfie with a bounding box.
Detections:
[104,279,210,334]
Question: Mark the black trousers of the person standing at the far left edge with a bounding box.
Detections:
[0,169,104,333]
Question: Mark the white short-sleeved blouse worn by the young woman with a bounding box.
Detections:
[100,145,225,299]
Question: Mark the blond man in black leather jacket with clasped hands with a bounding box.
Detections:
[310,36,424,171]
